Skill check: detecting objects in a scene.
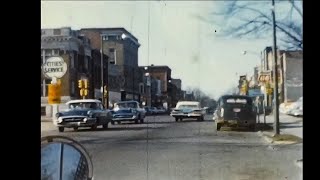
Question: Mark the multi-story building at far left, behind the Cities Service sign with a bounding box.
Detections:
[41,27,94,116]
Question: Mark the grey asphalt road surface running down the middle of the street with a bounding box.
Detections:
[41,116,302,180]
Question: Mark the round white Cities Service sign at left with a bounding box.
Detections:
[42,56,67,78]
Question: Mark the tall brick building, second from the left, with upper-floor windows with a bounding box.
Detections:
[79,28,143,101]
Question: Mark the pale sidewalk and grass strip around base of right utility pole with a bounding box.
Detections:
[260,113,303,144]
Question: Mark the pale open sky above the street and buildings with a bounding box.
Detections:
[41,1,286,98]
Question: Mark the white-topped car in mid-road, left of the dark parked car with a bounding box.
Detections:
[170,101,205,121]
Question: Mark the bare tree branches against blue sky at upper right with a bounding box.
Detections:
[202,0,303,49]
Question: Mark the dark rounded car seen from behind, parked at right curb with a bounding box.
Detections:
[215,95,256,131]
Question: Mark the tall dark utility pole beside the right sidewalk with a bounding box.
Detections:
[272,0,280,135]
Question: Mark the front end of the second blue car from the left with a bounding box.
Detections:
[111,108,143,124]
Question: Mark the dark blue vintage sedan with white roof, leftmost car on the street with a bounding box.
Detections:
[53,99,112,132]
